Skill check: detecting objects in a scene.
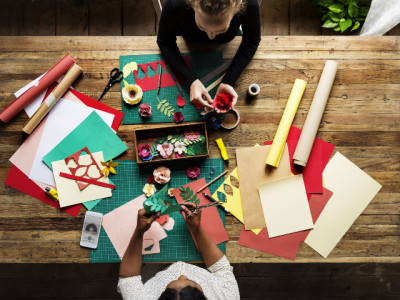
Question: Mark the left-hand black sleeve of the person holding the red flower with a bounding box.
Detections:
[157,0,198,86]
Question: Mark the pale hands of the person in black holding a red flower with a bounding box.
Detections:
[190,79,238,113]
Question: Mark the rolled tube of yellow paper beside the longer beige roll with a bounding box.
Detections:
[265,79,307,167]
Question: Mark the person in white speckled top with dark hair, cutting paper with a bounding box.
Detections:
[118,203,240,300]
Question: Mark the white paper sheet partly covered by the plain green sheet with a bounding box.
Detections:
[29,98,114,186]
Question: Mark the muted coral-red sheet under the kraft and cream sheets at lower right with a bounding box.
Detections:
[239,188,333,260]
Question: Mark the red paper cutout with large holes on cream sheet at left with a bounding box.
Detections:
[64,147,104,190]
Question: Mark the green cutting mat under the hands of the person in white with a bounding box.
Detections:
[90,159,226,263]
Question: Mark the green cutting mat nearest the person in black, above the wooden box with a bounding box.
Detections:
[119,51,222,124]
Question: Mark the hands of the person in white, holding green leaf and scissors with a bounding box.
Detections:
[136,202,201,235]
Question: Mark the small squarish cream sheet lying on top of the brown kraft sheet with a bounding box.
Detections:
[258,175,313,238]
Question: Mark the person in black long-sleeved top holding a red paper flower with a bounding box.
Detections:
[157,0,261,112]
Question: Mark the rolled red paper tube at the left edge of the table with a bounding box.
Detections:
[0,54,75,123]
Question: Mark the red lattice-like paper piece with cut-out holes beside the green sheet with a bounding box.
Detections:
[60,147,104,190]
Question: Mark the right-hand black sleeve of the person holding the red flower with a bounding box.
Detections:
[222,0,261,86]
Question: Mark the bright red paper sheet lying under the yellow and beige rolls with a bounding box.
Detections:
[264,126,335,194]
